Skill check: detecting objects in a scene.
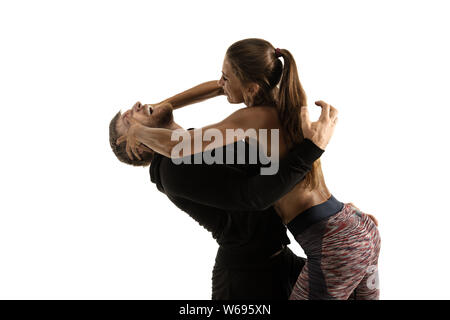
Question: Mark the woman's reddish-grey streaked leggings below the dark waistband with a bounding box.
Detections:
[290,203,380,300]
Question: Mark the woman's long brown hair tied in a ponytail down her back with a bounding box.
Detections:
[226,38,323,190]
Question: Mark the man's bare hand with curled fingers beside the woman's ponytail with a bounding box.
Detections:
[301,100,338,150]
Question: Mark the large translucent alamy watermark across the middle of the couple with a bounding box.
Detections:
[171,128,280,175]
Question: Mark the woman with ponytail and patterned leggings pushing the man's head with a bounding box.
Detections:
[118,39,380,299]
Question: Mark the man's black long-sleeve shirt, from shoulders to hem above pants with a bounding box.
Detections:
[150,139,323,264]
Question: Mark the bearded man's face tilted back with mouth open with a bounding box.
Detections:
[116,102,173,135]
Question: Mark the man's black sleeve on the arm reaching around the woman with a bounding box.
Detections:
[161,139,323,211]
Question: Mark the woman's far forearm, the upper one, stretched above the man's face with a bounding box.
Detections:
[155,80,223,109]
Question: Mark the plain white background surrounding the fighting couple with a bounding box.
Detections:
[0,0,450,299]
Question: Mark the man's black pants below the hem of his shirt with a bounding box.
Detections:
[212,247,306,300]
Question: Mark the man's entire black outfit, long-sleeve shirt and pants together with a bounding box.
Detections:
[150,136,323,299]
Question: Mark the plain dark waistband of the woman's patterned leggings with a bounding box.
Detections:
[287,195,344,236]
